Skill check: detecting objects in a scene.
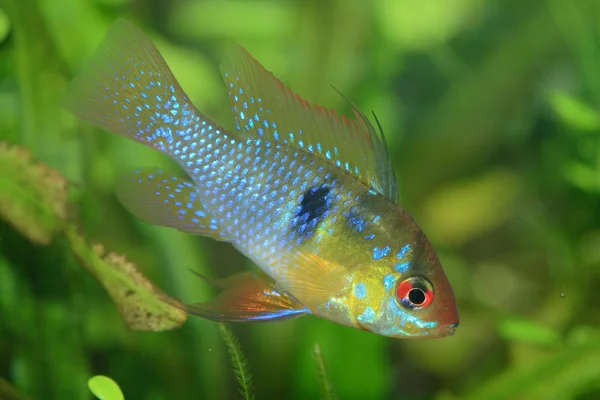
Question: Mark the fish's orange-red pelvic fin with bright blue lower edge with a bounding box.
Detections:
[185,272,309,322]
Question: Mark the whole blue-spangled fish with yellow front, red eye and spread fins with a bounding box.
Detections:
[62,18,459,339]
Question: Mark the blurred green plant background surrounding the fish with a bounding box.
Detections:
[0,0,600,400]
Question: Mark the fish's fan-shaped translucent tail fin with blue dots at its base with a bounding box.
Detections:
[63,19,207,153]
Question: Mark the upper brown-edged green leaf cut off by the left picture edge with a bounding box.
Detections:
[0,142,67,244]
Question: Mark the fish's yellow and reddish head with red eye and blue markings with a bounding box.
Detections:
[352,225,459,339]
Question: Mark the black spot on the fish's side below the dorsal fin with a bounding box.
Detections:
[291,185,331,242]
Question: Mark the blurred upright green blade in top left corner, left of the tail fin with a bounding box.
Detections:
[2,0,83,181]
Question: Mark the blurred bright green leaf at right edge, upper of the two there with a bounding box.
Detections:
[548,91,600,131]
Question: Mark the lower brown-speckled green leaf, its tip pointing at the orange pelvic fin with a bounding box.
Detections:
[67,226,187,331]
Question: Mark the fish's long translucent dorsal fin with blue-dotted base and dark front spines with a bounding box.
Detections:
[221,46,398,203]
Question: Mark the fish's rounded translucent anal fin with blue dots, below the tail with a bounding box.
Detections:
[116,169,227,241]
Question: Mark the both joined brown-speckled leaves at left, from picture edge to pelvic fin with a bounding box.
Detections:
[0,142,187,331]
